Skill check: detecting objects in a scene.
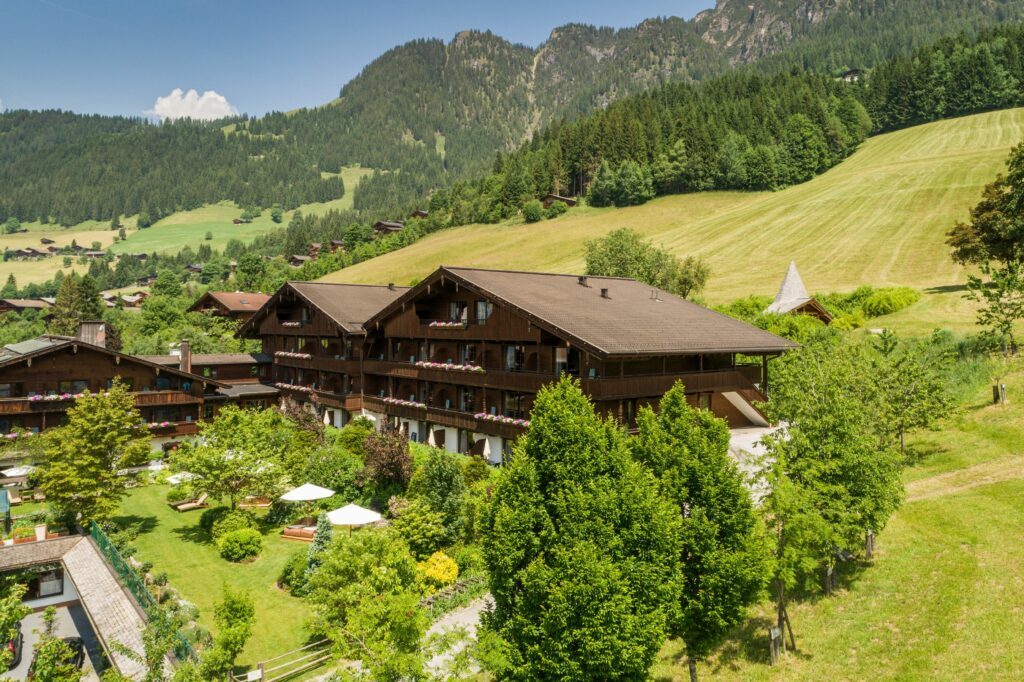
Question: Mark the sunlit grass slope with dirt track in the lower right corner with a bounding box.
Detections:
[653,364,1024,680]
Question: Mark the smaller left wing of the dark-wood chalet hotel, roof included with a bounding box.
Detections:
[239,282,408,426]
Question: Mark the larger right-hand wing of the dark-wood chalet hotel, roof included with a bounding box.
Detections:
[362,266,796,462]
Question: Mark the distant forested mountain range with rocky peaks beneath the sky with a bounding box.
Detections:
[0,0,1024,224]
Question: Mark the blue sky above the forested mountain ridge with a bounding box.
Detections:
[0,0,714,116]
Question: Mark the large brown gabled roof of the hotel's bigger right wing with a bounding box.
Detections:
[368,265,797,357]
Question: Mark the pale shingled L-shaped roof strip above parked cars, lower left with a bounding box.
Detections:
[0,536,145,680]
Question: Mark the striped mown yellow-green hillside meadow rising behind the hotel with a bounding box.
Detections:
[325,109,1024,329]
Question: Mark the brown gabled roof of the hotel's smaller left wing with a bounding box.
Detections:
[238,282,409,337]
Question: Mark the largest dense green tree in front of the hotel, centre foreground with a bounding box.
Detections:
[482,379,679,680]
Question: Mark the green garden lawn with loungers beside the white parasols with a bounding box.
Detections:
[117,485,309,666]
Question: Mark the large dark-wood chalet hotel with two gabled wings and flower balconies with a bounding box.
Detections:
[240,266,795,463]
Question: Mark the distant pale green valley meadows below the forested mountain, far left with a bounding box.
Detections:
[0,168,373,286]
